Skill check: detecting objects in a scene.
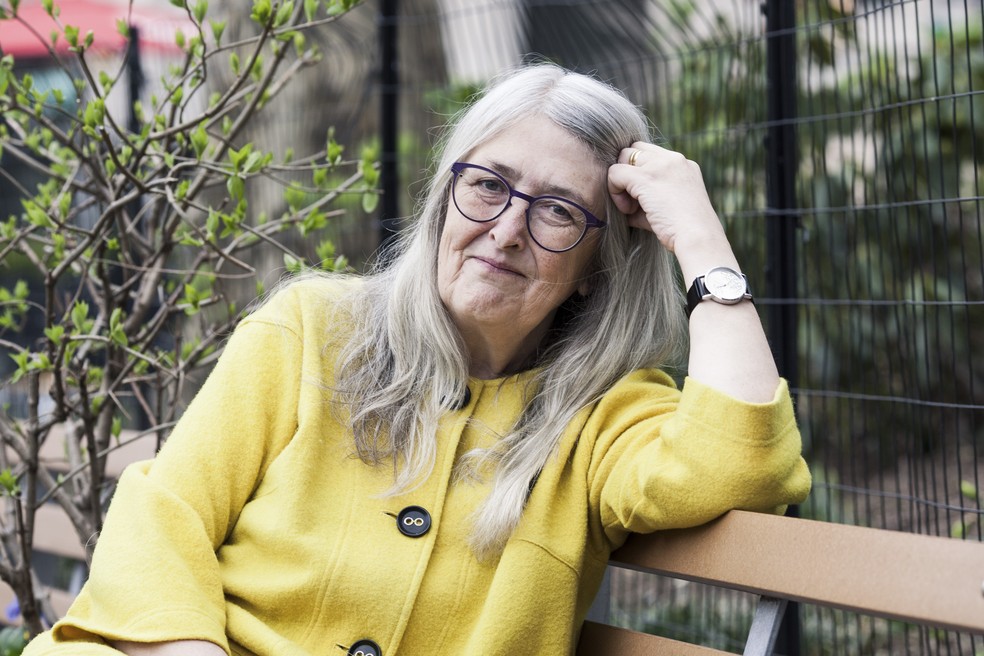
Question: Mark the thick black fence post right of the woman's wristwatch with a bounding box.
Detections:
[762,0,801,656]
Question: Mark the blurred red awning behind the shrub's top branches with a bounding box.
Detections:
[0,0,195,59]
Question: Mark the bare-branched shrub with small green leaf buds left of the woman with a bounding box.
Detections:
[0,0,368,633]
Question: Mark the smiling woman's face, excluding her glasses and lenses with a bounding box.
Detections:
[437,116,608,356]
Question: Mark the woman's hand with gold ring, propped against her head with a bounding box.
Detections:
[608,141,727,256]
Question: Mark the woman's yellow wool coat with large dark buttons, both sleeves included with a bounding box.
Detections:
[26,281,810,656]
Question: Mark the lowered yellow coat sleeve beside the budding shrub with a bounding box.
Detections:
[26,291,302,656]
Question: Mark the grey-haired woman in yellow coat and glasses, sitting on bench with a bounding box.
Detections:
[27,65,810,656]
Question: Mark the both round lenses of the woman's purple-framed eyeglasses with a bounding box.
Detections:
[452,166,587,251]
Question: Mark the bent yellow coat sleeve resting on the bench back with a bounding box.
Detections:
[585,371,811,548]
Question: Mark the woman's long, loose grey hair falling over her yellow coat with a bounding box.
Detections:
[335,64,686,557]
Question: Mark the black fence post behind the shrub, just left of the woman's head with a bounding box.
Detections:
[378,0,400,252]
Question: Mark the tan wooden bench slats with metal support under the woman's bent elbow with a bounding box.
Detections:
[578,511,984,656]
